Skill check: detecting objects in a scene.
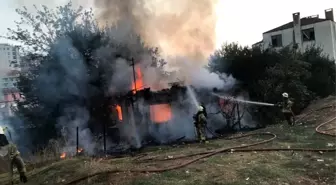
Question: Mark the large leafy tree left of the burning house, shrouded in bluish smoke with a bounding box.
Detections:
[8,3,165,146]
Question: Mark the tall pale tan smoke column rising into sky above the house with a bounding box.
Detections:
[94,0,230,92]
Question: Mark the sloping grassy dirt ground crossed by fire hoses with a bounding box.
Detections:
[0,97,336,185]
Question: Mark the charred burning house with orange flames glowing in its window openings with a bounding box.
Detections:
[107,82,187,143]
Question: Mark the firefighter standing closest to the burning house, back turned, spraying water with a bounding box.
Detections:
[194,106,208,143]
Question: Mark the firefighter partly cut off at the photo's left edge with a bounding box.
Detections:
[0,126,27,184]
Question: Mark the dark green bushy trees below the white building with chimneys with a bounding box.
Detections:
[209,43,336,122]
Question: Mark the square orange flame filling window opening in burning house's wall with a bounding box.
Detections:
[150,104,172,123]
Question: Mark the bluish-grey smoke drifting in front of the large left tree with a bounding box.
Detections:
[35,37,95,154]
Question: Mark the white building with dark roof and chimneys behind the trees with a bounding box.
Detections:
[254,9,336,60]
